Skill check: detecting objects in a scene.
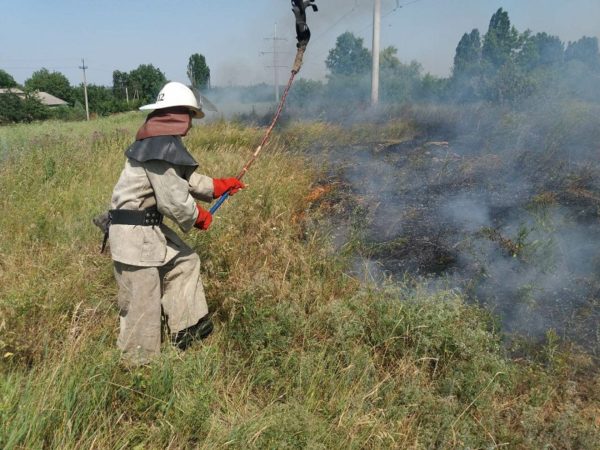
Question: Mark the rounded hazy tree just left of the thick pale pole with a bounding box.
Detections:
[325,32,371,76]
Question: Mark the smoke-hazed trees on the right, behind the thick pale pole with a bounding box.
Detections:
[290,8,600,110]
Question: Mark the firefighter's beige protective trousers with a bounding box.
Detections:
[114,248,208,364]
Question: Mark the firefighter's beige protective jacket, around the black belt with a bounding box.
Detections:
[109,158,213,267]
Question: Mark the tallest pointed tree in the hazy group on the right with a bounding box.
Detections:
[481,8,519,69]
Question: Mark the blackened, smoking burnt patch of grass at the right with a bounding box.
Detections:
[308,107,600,359]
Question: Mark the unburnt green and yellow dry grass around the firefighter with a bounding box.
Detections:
[0,114,600,449]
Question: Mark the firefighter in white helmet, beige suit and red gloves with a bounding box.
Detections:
[108,82,245,364]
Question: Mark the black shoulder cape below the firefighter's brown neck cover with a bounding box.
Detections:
[125,136,198,168]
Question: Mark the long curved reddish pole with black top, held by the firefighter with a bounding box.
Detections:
[210,0,318,215]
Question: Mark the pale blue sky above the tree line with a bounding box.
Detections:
[0,0,600,86]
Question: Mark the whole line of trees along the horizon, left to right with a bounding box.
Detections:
[0,8,600,123]
